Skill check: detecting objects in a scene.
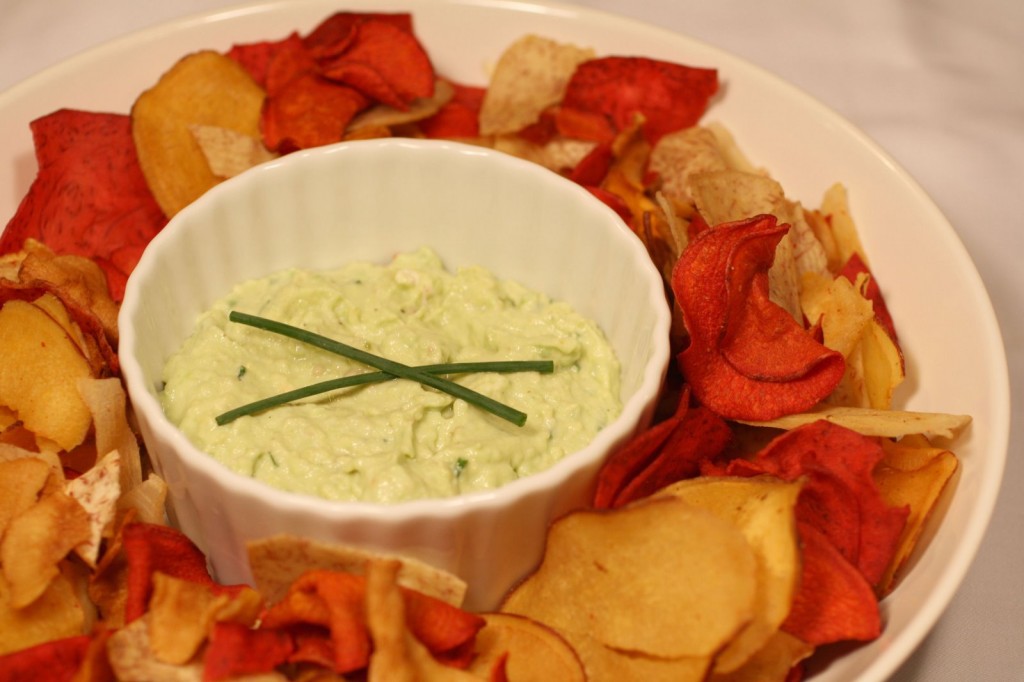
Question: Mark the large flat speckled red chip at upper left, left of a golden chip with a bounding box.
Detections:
[0,109,166,300]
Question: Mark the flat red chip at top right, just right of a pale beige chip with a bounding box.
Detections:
[561,56,718,144]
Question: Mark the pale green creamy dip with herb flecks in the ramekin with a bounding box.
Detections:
[161,248,622,503]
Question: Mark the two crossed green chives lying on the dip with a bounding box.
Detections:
[216,310,555,426]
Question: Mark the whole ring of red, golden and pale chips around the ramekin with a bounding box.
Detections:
[0,6,970,682]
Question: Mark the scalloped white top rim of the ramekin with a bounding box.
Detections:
[118,138,672,522]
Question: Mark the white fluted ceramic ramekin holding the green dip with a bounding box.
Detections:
[119,139,670,608]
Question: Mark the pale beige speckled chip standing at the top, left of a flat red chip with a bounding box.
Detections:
[479,35,595,135]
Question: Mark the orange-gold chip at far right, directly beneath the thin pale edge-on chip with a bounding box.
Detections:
[873,438,959,595]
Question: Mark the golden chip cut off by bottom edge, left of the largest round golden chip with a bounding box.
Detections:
[468,613,587,682]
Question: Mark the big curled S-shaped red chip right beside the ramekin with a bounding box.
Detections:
[672,215,846,420]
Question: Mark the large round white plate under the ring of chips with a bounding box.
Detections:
[0,0,1010,682]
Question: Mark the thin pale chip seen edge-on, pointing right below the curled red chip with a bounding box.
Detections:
[740,406,971,438]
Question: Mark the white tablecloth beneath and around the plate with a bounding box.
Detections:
[0,0,1024,682]
